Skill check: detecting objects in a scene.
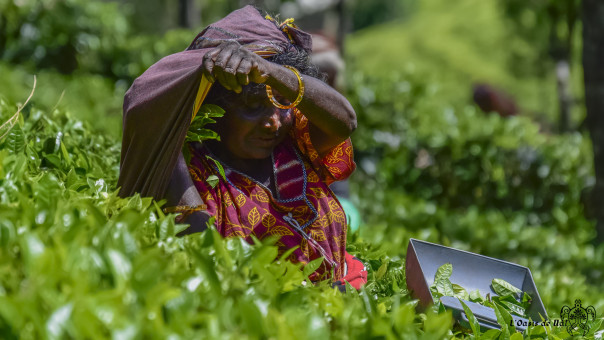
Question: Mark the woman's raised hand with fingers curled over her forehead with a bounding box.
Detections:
[202,41,271,93]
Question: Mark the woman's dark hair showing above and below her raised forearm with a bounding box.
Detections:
[205,45,325,106]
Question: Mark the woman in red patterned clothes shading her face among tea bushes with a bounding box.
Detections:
[118,6,366,288]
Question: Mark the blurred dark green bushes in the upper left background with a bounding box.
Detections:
[0,0,195,82]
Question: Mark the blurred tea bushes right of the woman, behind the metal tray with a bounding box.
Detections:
[348,68,604,330]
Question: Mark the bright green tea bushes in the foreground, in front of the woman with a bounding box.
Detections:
[0,77,604,339]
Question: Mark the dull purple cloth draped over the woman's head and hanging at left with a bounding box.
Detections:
[118,6,312,200]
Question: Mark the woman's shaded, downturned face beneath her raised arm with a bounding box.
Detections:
[215,91,294,159]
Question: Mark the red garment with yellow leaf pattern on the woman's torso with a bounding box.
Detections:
[189,109,367,289]
